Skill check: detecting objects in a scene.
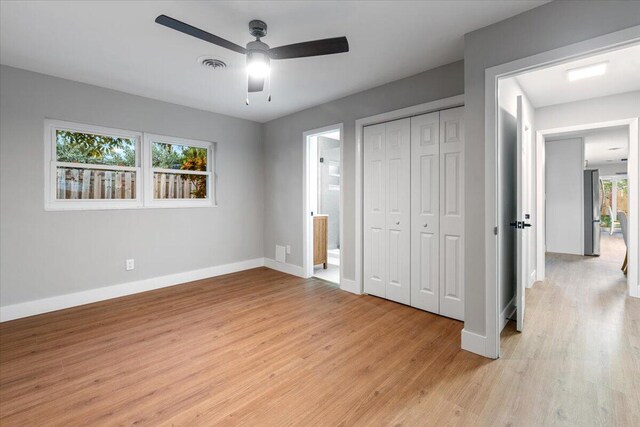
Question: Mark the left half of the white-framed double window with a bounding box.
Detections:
[45,121,142,210]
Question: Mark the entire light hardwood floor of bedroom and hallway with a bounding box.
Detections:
[0,236,640,427]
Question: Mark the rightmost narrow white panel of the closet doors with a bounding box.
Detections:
[440,107,464,320]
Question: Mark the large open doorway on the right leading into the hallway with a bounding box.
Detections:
[497,44,640,344]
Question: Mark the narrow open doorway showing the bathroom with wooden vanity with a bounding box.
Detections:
[303,124,343,285]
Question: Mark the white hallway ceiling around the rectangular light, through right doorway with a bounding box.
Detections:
[516,45,640,108]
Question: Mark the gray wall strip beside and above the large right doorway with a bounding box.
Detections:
[464,1,640,335]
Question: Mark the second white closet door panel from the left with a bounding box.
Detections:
[385,119,411,304]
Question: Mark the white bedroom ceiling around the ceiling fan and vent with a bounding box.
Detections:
[0,0,545,122]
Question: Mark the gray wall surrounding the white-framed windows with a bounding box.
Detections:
[0,66,264,306]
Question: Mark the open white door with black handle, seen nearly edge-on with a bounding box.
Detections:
[515,96,530,331]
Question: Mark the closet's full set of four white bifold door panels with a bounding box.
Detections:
[363,107,464,320]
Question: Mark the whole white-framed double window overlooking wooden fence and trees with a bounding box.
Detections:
[45,120,215,210]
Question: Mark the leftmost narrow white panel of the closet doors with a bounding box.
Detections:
[363,123,387,298]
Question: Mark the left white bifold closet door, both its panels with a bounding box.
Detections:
[364,119,411,304]
